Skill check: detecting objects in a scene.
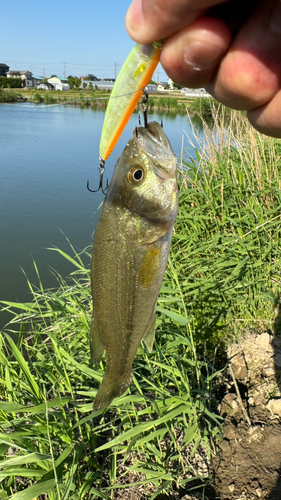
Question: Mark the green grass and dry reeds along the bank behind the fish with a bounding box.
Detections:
[0,108,281,500]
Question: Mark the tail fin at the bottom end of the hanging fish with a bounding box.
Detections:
[93,370,133,411]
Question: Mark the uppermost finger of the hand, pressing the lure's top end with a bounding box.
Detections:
[126,0,227,44]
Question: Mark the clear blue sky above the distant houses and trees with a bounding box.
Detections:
[0,0,167,81]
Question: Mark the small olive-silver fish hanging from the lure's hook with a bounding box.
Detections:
[90,121,178,411]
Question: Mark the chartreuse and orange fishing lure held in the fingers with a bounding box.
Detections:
[99,40,164,162]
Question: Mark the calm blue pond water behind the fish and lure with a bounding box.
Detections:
[0,103,201,328]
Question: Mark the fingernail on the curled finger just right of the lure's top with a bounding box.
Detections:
[184,38,225,71]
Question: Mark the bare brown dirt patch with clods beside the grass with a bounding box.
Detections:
[211,332,281,500]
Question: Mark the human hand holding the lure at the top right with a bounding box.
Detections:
[126,0,281,137]
